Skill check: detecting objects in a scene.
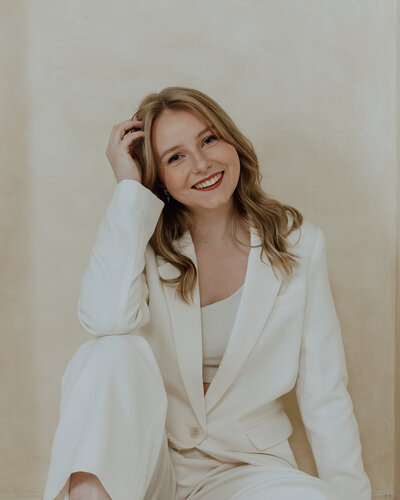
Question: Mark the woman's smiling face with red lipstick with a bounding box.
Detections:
[152,109,240,213]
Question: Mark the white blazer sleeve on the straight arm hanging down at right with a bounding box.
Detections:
[296,228,371,500]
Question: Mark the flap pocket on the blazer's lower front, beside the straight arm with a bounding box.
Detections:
[245,408,293,450]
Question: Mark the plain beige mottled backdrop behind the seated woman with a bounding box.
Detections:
[0,0,400,500]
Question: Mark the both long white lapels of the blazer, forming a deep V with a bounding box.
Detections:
[158,227,282,426]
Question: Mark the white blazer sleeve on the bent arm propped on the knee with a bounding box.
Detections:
[78,179,164,336]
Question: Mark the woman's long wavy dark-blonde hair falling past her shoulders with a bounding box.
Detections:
[133,87,303,304]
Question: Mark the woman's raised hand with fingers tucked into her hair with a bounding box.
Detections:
[106,119,144,183]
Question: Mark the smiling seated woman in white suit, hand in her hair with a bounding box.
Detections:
[45,87,371,500]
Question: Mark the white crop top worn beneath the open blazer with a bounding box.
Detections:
[201,285,243,382]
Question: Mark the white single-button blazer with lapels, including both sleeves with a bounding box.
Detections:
[78,180,371,500]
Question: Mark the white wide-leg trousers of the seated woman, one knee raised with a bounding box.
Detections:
[44,334,337,500]
